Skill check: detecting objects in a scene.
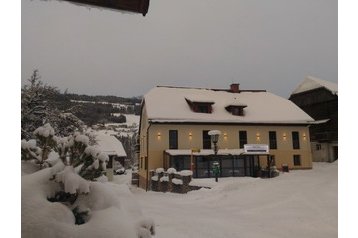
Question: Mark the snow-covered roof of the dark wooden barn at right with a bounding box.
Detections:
[292,76,338,95]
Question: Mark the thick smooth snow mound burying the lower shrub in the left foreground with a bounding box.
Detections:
[21,168,155,238]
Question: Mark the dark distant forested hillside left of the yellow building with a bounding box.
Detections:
[53,92,142,126]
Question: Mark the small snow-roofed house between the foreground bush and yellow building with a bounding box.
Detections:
[95,131,127,181]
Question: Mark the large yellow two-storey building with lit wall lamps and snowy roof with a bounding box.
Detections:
[139,84,314,189]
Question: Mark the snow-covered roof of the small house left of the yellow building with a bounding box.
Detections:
[95,131,127,157]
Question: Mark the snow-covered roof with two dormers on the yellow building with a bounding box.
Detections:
[144,87,314,124]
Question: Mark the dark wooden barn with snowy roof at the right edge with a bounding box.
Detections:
[289,76,338,162]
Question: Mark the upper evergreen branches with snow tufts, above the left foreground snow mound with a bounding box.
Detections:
[21,123,109,180]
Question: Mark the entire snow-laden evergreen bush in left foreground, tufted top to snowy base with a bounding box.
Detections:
[21,124,154,235]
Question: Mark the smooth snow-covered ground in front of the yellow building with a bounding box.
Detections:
[118,162,338,238]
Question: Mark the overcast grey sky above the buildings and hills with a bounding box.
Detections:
[21,0,338,98]
